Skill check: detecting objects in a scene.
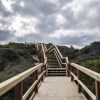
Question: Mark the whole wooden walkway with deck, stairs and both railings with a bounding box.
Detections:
[0,43,100,100]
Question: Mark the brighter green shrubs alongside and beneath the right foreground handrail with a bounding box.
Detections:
[80,59,100,93]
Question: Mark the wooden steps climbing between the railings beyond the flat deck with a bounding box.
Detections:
[46,52,66,76]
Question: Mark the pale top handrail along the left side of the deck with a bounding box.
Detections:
[0,63,45,96]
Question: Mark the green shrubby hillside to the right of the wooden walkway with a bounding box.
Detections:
[58,41,100,100]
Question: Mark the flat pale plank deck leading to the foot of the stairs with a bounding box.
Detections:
[33,76,84,100]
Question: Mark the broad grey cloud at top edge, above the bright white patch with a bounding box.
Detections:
[12,0,58,17]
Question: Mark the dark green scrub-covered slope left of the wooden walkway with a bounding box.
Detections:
[0,43,36,82]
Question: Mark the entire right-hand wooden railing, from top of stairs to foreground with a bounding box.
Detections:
[48,46,100,100]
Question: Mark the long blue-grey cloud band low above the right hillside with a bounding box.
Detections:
[56,32,100,47]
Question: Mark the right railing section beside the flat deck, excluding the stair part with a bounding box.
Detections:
[68,63,100,100]
